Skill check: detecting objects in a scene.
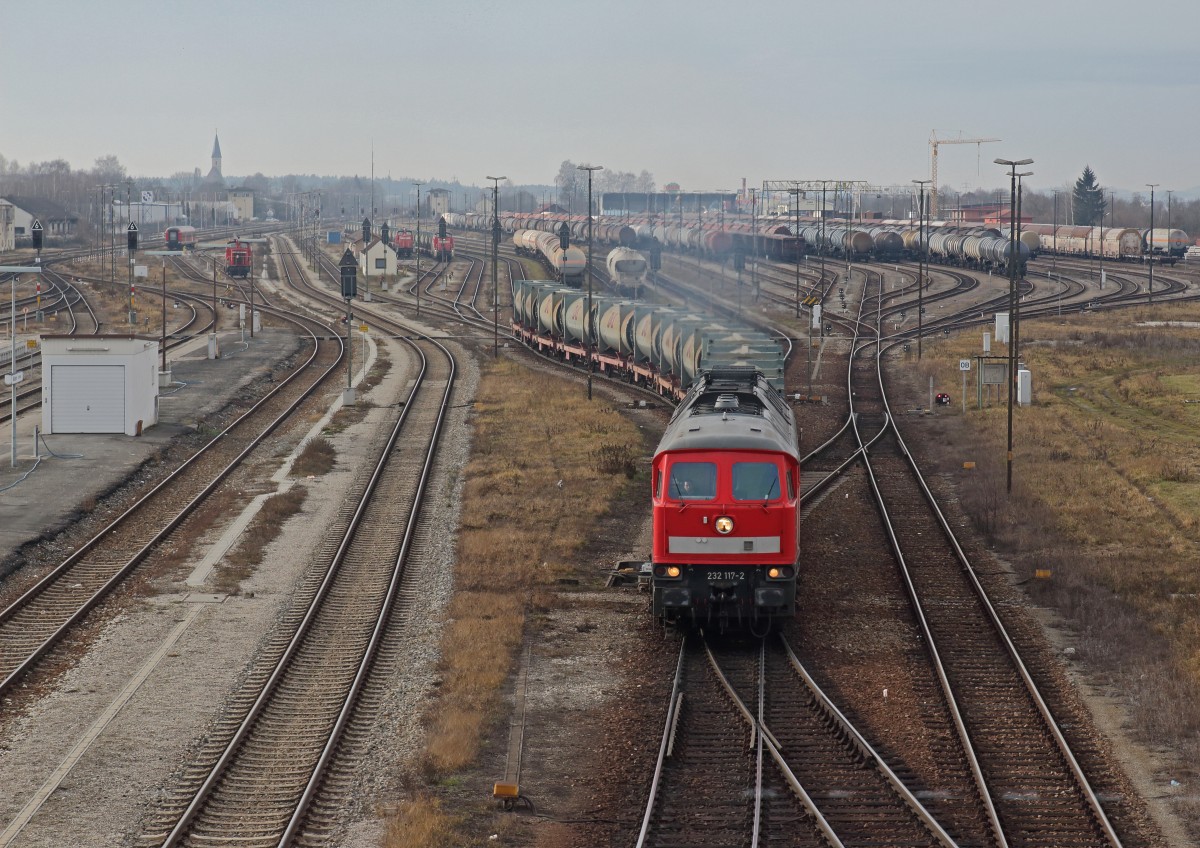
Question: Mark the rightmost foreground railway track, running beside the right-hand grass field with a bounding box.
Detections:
[835,273,1121,848]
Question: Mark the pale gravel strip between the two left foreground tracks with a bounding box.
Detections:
[0,333,432,846]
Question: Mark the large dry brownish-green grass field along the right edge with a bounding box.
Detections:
[910,306,1200,830]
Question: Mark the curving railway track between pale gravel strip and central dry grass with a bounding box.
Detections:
[143,304,455,846]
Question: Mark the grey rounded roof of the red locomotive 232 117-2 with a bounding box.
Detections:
[655,366,799,459]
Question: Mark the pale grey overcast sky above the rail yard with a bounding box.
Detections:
[0,0,1200,191]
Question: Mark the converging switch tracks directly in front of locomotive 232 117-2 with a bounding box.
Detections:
[636,638,961,848]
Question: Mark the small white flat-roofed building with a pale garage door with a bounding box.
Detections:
[42,333,158,435]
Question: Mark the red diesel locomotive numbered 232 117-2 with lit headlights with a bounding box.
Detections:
[652,366,800,635]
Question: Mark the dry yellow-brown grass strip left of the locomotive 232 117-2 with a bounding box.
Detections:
[385,361,641,848]
